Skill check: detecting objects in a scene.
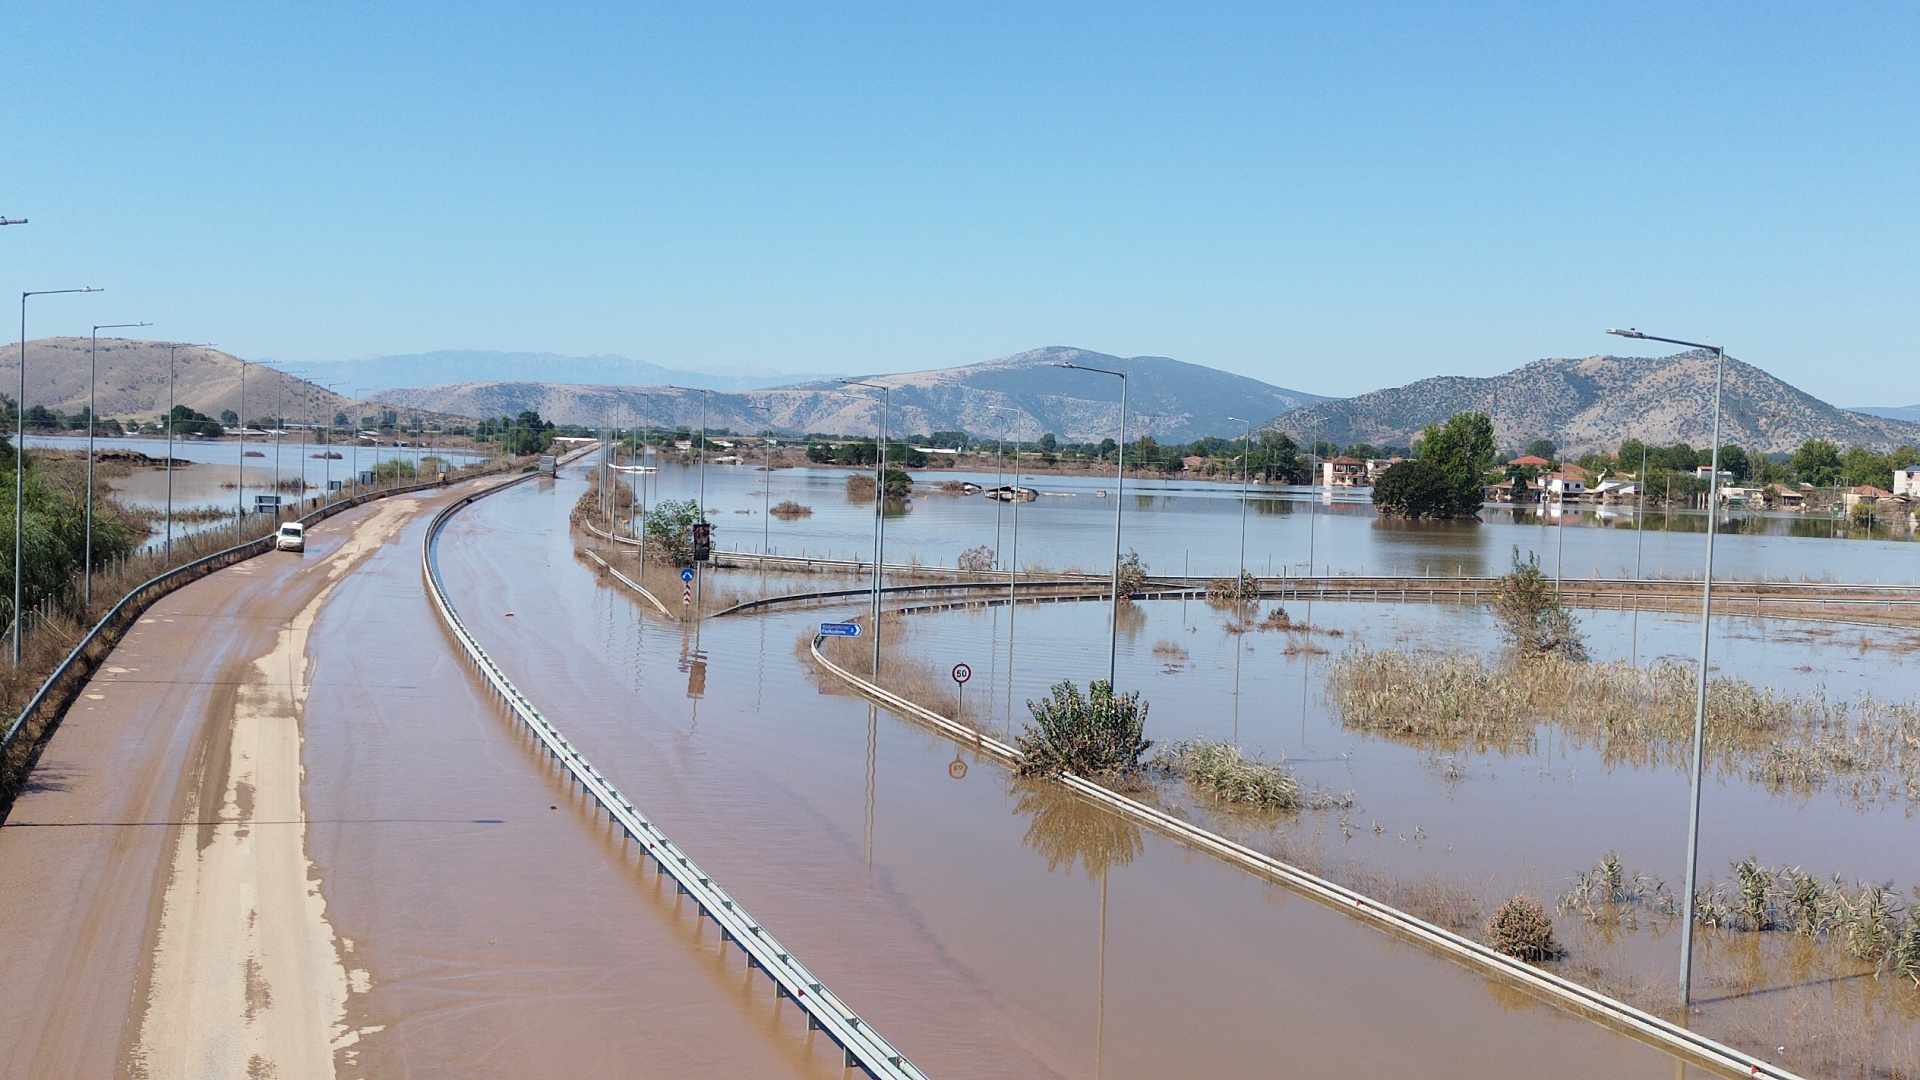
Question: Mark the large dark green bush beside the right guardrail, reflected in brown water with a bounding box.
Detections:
[1016,678,1154,776]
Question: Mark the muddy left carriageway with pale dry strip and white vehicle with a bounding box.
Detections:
[0,480,841,1078]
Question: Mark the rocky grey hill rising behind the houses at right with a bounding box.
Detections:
[1275,352,1920,454]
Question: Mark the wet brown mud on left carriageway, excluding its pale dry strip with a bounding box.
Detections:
[0,480,841,1078]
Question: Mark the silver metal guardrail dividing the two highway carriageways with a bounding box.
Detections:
[420,448,925,1080]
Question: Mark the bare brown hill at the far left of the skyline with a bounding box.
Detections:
[0,338,439,423]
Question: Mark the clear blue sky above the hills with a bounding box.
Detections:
[0,4,1920,404]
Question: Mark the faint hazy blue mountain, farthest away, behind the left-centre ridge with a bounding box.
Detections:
[301,350,831,398]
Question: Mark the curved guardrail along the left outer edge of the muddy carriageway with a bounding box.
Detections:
[0,463,486,807]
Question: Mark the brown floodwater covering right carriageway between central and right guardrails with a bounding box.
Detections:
[440,463,1712,1078]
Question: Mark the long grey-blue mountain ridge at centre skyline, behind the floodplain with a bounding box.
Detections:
[378,346,1321,442]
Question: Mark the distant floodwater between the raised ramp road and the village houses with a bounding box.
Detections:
[610,453,1920,584]
